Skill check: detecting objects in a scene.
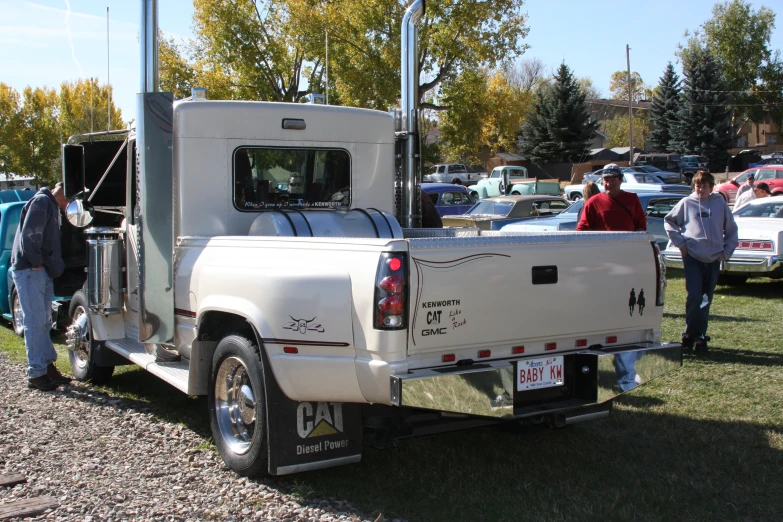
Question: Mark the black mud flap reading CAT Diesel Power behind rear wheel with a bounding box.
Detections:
[266,379,362,475]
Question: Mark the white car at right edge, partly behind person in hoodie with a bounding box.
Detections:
[662,196,783,284]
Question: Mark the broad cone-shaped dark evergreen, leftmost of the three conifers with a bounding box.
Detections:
[520,64,596,162]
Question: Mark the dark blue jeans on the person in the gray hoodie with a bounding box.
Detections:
[682,255,720,341]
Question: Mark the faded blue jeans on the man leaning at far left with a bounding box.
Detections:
[11,269,57,379]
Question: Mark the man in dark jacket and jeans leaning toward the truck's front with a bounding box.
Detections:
[11,183,70,391]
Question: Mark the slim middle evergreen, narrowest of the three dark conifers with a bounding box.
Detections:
[650,62,682,152]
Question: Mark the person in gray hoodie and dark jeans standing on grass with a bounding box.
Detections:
[664,170,737,353]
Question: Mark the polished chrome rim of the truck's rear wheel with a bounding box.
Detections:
[215,356,258,455]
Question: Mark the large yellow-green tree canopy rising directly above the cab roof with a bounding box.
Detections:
[166,0,528,110]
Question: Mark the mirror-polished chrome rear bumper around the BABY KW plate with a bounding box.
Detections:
[390,343,682,422]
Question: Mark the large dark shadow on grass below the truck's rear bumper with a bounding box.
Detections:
[284,406,783,521]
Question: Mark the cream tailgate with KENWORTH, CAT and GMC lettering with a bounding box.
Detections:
[407,230,662,367]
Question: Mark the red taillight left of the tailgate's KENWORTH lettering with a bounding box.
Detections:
[374,252,408,330]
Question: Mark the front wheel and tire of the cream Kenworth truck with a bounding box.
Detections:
[66,290,114,384]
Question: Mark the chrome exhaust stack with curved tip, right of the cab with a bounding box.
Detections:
[400,0,425,228]
